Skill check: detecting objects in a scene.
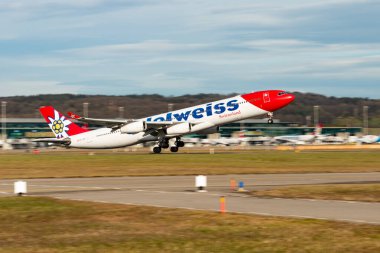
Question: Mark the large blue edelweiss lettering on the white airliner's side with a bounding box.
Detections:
[146,99,239,122]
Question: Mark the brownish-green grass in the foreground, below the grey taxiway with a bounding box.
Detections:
[0,197,380,253]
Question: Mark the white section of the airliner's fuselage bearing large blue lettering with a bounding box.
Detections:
[69,96,268,148]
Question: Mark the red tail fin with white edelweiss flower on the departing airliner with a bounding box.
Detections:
[40,106,88,139]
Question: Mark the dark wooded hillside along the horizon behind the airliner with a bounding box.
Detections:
[0,92,380,127]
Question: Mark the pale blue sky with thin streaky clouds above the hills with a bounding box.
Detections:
[0,0,380,99]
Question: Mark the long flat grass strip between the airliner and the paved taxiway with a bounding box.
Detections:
[0,151,380,178]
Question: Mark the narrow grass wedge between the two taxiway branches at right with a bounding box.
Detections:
[250,184,380,202]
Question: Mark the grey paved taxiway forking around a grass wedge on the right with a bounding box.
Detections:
[0,172,380,224]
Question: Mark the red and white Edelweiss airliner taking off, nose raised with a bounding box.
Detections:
[34,90,295,154]
